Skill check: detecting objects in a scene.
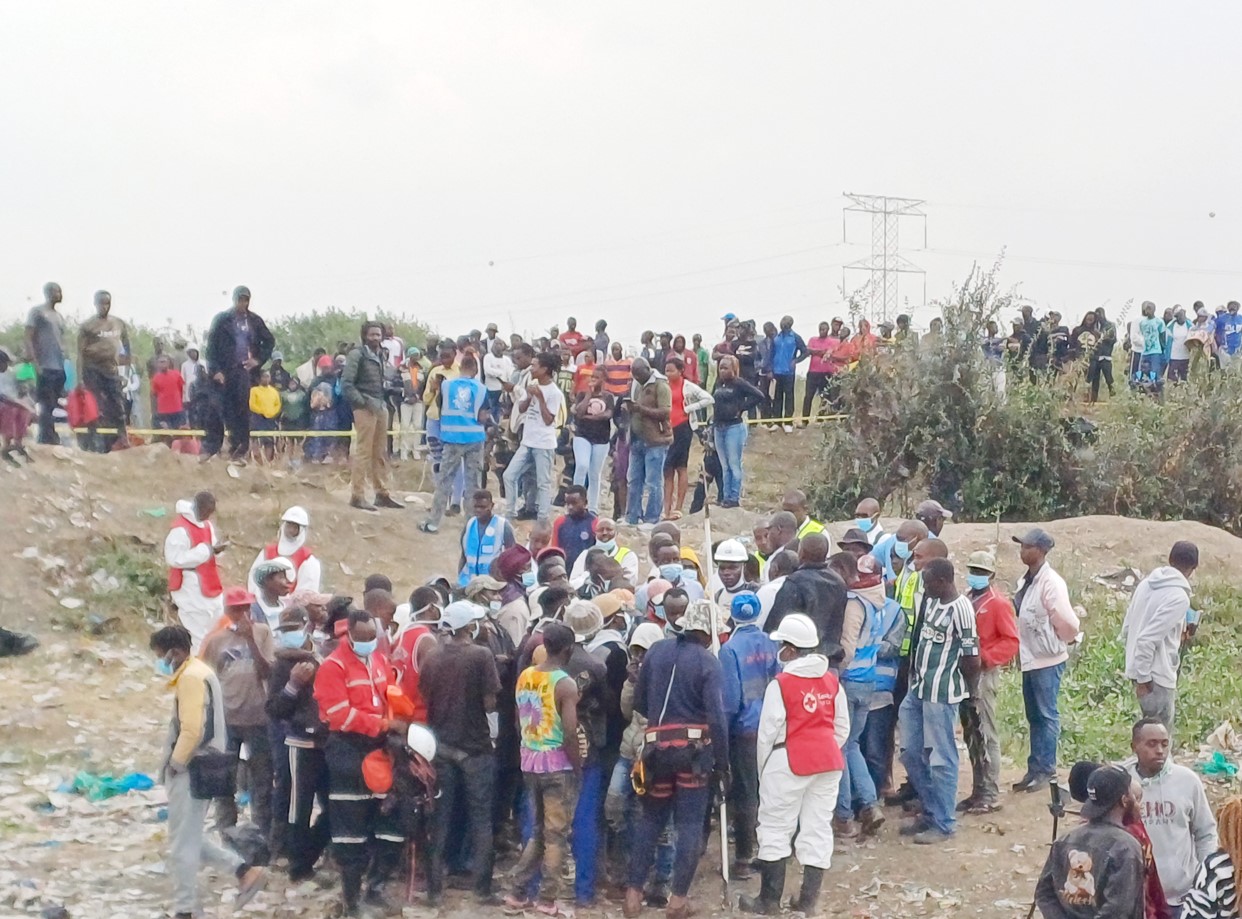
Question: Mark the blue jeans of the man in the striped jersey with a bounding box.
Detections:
[897,695,958,833]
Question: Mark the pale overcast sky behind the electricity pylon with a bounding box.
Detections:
[0,0,1242,339]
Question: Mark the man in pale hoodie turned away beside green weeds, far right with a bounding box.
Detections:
[1122,541,1199,734]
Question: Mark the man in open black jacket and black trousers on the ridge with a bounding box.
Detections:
[202,287,276,462]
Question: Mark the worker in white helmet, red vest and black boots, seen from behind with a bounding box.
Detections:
[739,612,850,915]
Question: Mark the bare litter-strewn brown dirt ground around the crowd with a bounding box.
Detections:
[0,430,1242,919]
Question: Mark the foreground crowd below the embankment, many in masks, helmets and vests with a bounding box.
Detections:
[152,486,1242,919]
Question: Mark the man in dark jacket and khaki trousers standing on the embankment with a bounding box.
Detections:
[340,322,405,512]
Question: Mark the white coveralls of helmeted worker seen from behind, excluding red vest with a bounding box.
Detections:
[758,654,850,869]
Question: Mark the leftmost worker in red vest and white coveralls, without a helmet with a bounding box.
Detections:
[164,492,229,654]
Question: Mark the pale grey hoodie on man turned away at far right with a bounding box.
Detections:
[1122,566,1190,689]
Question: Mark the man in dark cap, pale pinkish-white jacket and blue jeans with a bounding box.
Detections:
[1013,527,1078,791]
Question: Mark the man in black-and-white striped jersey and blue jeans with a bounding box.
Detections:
[898,559,979,846]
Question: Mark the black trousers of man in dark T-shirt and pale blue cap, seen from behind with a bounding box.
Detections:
[434,750,496,897]
